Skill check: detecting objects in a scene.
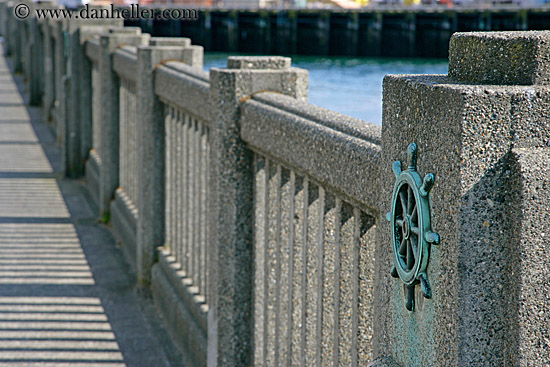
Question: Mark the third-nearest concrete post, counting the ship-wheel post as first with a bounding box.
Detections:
[136,38,191,287]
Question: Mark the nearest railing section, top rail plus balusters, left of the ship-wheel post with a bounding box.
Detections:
[240,92,380,366]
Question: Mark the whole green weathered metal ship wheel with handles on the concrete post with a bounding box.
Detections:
[386,143,439,311]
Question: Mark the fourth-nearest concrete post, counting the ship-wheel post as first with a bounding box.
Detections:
[98,27,149,218]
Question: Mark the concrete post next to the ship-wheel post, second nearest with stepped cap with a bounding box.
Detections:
[207,57,307,367]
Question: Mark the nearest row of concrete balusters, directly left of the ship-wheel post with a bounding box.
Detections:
[254,154,375,366]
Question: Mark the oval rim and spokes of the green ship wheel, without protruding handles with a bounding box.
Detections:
[392,174,423,285]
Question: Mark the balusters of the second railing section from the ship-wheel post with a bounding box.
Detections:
[165,105,210,303]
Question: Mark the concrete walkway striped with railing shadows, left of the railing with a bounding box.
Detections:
[0,44,185,367]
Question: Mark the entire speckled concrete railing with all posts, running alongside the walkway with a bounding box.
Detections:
[0,3,550,366]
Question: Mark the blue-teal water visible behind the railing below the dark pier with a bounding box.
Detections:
[204,52,448,125]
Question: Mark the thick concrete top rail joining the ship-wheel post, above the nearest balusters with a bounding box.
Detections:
[241,92,381,215]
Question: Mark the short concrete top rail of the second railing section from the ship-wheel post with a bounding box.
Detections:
[155,62,210,122]
